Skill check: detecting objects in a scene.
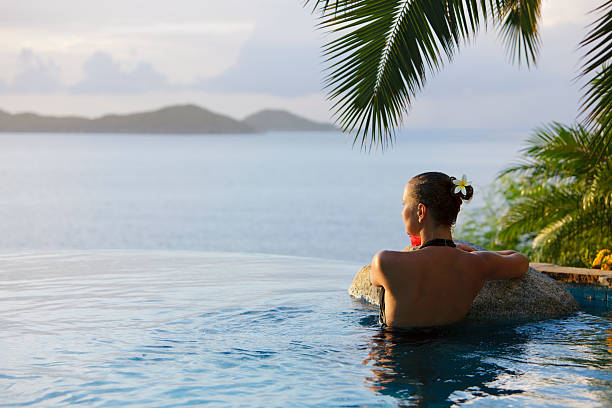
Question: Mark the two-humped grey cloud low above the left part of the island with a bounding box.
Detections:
[70,52,169,94]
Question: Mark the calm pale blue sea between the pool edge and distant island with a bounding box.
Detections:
[0,131,526,263]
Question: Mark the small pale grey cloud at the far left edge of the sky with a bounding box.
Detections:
[8,48,62,93]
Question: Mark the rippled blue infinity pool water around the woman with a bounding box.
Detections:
[0,250,612,407]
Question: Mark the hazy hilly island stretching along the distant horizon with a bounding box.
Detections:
[0,105,337,134]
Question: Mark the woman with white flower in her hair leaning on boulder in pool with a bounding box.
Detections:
[370,172,529,328]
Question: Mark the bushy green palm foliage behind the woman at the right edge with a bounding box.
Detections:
[457,123,612,267]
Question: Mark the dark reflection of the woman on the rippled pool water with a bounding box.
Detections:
[363,327,528,406]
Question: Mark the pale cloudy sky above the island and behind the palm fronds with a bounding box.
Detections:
[0,0,602,130]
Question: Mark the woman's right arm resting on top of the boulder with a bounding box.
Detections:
[473,250,529,280]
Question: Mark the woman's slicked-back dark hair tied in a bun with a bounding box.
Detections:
[408,171,474,225]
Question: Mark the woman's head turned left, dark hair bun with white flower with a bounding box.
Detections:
[403,172,474,233]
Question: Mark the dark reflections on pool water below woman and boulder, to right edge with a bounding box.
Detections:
[362,312,612,406]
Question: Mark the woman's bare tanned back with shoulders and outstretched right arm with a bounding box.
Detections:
[371,247,527,327]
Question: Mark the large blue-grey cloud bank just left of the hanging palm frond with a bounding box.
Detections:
[194,30,323,97]
